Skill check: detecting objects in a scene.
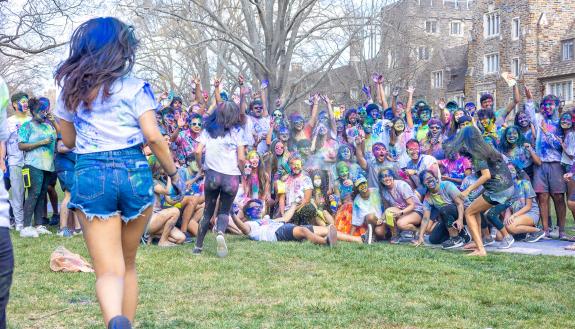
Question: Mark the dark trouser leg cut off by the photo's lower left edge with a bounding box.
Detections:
[0,227,14,329]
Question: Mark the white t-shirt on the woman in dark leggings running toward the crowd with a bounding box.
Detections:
[198,127,247,176]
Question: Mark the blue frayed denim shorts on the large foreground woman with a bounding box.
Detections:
[68,146,154,223]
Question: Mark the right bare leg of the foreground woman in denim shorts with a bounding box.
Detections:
[122,207,152,323]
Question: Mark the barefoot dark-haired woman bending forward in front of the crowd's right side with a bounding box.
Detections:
[443,126,514,256]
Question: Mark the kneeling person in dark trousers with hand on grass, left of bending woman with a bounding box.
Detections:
[414,170,471,249]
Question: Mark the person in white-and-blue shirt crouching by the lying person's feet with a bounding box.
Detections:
[351,177,386,243]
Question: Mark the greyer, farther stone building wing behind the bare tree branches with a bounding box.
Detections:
[302,0,475,107]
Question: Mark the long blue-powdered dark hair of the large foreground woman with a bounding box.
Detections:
[54,17,138,112]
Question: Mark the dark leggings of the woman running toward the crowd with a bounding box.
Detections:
[196,169,240,248]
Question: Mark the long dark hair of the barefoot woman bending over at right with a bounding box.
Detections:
[443,126,503,162]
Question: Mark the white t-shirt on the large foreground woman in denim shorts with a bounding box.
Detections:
[55,77,156,154]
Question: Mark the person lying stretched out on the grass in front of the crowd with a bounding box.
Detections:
[232,199,367,246]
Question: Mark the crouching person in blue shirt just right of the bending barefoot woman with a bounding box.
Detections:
[504,164,545,242]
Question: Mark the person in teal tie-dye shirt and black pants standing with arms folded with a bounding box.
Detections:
[18,98,57,232]
